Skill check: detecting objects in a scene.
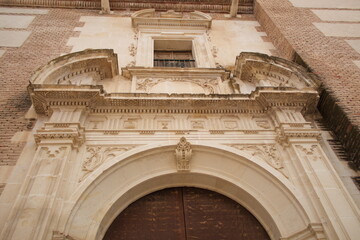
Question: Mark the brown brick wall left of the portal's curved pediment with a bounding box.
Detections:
[0,9,86,166]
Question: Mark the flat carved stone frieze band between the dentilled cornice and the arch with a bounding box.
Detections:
[86,114,274,134]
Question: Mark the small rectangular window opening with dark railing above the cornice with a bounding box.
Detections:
[154,40,196,68]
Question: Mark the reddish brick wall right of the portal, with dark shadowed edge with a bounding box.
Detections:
[254,0,360,169]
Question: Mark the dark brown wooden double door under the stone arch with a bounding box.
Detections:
[104,187,270,240]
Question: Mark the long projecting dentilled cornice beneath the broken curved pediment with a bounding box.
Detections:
[28,84,318,114]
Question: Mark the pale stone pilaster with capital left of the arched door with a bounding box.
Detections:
[0,107,85,240]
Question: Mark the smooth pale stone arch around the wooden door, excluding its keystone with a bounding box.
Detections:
[62,144,311,240]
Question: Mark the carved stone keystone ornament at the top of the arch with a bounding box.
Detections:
[175,137,192,172]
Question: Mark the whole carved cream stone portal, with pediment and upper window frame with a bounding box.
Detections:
[0,9,360,240]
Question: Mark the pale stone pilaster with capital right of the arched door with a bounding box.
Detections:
[274,107,360,239]
